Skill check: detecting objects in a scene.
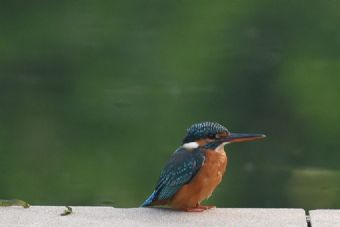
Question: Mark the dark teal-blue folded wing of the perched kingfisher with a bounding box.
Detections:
[154,147,204,200]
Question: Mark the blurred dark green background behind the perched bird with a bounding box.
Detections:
[0,0,340,209]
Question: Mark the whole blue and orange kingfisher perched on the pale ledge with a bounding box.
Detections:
[141,122,266,212]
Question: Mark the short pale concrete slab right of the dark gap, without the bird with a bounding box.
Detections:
[309,210,340,227]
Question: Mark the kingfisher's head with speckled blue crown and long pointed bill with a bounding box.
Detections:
[183,122,266,149]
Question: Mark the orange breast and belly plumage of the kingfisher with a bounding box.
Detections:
[169,148,227,209]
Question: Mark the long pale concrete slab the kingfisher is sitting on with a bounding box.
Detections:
[0,206,307,227]
